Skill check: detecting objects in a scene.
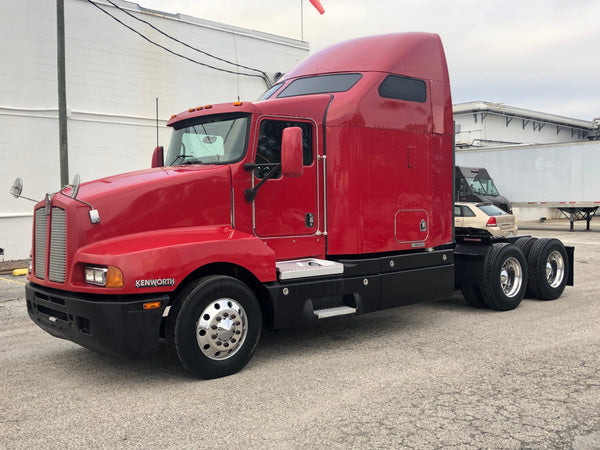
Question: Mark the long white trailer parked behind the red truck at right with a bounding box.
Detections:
[456,141,600,230]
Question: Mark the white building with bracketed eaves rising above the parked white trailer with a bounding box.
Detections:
[453,102,598,149]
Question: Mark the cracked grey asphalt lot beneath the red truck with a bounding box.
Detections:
[0,222,600,449]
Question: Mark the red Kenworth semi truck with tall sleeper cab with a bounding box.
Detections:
[13,33,573,378]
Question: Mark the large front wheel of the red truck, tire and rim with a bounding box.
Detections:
[166,276,262,379]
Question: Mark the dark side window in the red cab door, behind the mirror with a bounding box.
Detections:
[254,119,313,178]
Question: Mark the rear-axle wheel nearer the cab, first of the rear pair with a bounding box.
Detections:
[481,242,527,311]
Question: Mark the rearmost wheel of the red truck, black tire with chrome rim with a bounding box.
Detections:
[527,239,569,300]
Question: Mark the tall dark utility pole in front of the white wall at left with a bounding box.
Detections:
[56,0,69,188]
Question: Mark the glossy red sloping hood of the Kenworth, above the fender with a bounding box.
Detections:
[53,165,231,247]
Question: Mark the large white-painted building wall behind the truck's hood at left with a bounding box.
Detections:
[0,0,309,260]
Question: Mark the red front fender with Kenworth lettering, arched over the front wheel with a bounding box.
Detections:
[69,226,276,295]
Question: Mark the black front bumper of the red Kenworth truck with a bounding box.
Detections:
[25,283,169,357]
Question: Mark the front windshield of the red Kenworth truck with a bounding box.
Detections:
[165,114,250,166]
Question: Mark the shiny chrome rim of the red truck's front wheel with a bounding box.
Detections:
[196,298,248,360]
